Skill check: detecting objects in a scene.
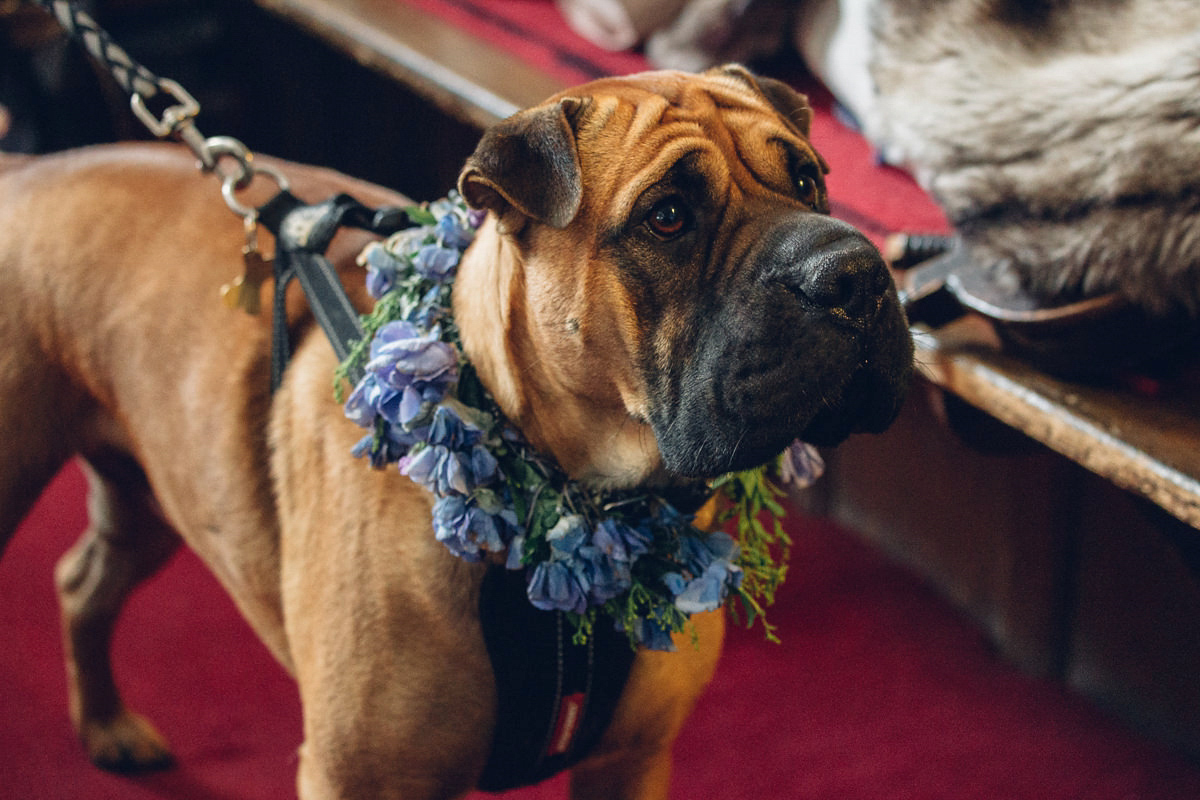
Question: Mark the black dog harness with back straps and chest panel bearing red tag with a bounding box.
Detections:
[258,191,634,792]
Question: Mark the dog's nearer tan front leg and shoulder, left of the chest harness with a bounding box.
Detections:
[272,338,496,800]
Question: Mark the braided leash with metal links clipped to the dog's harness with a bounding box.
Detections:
[34,0,288,221]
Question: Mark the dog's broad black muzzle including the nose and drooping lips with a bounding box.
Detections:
[652,212,912,476]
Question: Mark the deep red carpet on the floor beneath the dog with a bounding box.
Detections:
[7,460,1200,800]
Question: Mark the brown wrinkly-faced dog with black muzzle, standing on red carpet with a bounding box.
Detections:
[0,68,911,800]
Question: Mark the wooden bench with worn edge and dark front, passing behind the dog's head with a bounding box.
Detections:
[257,0,1200,756]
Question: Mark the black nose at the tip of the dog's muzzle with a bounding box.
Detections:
[775,213,892,320]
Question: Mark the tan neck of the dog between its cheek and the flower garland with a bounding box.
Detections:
[454,215,664,488]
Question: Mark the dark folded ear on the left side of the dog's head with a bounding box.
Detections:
[458,97,587,229]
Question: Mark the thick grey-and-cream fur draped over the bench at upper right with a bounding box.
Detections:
[860,0,1200,318]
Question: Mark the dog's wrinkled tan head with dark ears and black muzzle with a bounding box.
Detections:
[460,67,912,481]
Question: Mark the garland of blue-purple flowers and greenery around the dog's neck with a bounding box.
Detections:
[337,193,822,650]
